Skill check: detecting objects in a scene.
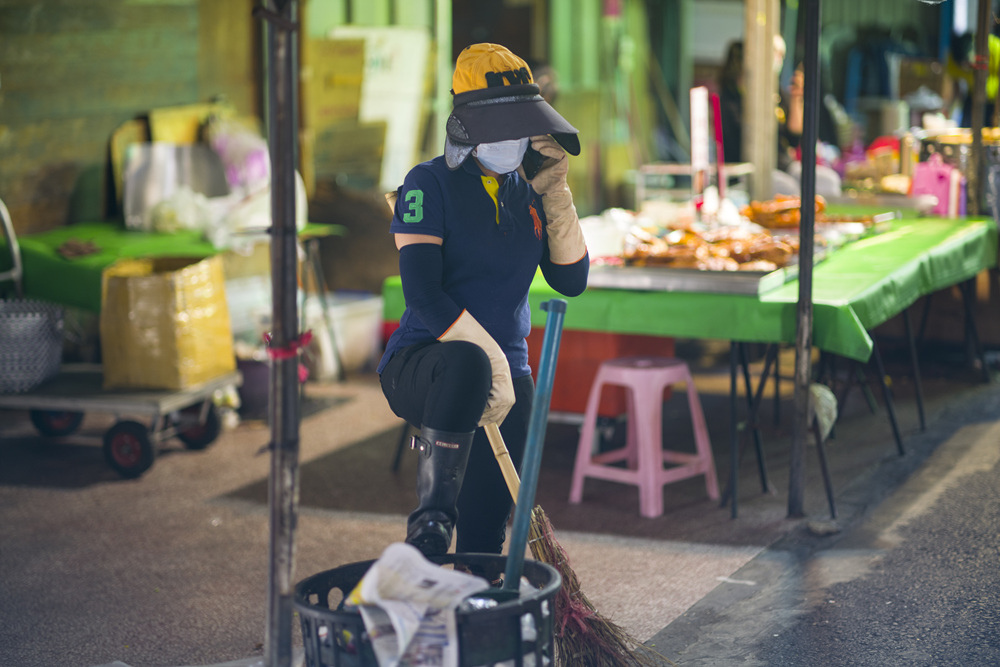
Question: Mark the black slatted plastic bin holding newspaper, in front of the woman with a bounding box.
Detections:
[295,554,562,667]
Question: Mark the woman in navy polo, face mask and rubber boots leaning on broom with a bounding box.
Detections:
[378,44,590,580]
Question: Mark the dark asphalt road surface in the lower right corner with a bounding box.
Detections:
[650,362,1000,667]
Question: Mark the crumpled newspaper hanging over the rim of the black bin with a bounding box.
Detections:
[345,542,490,667]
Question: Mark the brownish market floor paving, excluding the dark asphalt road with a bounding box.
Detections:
[0,347,993,667]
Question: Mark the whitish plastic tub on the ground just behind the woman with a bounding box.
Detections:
[303,291,382,380]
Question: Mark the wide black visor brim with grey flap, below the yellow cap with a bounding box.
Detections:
[444,83,580,169]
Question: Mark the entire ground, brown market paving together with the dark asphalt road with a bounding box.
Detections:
[0,342,1000,667]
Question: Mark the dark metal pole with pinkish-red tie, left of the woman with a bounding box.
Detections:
[254,0,300,667]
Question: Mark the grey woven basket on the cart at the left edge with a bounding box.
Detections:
[0,299,63,394]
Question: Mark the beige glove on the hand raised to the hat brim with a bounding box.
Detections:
[529,134,587,264]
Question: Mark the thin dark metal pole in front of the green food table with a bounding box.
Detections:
[788,0,820,517]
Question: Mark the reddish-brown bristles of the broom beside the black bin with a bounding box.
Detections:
[528,507,674,667]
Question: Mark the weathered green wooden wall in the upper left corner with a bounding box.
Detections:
[0,0,259,234]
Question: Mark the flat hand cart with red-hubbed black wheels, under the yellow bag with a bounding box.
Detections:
[0,364,243,479]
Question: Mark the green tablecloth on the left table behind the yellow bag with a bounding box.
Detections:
[0,222,343,312]
